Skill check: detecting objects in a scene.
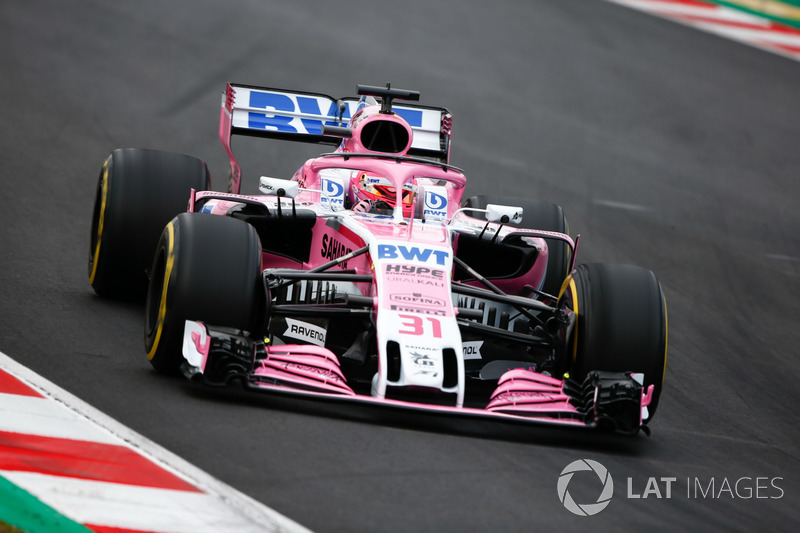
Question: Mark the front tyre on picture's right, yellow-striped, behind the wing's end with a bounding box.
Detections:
[558,263,667,421]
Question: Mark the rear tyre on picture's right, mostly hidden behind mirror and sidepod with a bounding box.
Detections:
[464,196,571,295]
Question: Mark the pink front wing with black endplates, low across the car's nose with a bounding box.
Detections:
[182,320,653,435]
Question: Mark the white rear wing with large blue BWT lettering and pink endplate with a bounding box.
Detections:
[219,83,452,193]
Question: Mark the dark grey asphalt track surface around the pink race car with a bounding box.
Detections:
[0,0,800,531]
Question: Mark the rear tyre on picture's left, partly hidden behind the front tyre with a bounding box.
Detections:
[89,148,210,298]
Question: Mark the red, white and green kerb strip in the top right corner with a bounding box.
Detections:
[607,0,800,61]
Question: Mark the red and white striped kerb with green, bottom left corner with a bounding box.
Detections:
[0,352,307,533]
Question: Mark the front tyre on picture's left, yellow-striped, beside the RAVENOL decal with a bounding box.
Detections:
[144,213,264,374]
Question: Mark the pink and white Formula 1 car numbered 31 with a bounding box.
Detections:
[89,84,667,434]
